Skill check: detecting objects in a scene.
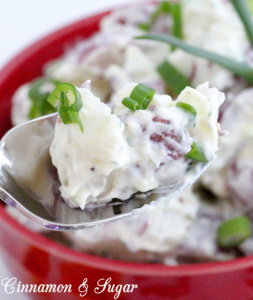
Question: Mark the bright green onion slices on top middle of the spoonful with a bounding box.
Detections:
[122,83,155,111]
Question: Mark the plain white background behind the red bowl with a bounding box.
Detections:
[0,0,137,300]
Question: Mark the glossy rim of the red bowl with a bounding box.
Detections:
[0,4,253,277]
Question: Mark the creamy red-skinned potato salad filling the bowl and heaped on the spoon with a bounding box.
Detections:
[8,0,253,265]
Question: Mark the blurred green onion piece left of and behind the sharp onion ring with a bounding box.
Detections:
[28,78,59,120]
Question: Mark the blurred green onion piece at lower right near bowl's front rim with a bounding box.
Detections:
[218,216,251,248]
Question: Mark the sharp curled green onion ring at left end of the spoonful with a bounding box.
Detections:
[47,83,83,132]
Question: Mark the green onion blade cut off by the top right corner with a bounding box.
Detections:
[231,0,253,46]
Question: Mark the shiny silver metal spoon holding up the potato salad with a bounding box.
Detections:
[0,113,208,230]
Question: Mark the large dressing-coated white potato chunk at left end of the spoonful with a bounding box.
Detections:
[50,88,129,208]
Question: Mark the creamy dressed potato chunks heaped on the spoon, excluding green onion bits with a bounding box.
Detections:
[50,83,224,209]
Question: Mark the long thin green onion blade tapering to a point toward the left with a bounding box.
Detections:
[136,34,253,83]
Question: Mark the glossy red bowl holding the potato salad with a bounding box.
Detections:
[0,5,253,300]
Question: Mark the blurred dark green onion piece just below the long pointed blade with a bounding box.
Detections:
[157,61,190,96]
